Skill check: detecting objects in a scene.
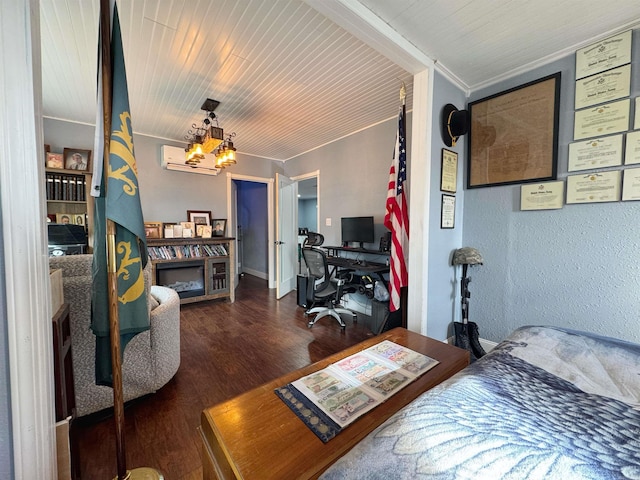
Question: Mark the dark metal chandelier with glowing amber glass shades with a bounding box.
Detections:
[185,98,236,168]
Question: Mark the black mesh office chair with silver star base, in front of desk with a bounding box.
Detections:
[302,240,357,330]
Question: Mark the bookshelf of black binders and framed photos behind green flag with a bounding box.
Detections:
[45,167,93,251]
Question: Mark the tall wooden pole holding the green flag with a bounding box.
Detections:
[100,0,127,480]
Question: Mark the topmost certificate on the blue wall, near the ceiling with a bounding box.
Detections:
[576,30,631,80]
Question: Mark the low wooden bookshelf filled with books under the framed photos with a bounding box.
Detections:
[147,237,235,304]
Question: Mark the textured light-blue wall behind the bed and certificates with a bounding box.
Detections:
[462,31,640,342]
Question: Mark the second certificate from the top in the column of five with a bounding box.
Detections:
[575,64,631,110]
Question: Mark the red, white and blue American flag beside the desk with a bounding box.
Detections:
[384,103,409,312]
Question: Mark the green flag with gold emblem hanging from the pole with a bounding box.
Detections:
[91,2,149,386]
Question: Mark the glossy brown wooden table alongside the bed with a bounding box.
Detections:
[200,328,469,480]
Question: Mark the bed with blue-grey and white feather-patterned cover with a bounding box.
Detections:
[321,326,640,480]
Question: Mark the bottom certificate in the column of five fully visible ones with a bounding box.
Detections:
[567,170,621,204]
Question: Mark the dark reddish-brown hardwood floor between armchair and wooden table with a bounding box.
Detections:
[74,276,372,480]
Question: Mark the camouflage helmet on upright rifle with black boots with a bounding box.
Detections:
[451,247,486,359]
